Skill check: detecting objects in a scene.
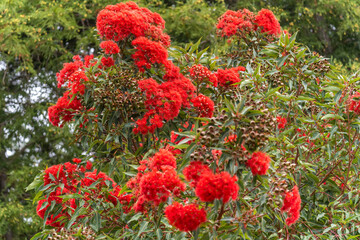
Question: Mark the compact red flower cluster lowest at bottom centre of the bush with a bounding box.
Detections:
[165,202,206,232]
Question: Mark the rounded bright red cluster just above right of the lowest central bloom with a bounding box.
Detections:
[195,171,239,203]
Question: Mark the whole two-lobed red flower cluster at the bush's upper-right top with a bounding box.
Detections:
[216,9,281,37]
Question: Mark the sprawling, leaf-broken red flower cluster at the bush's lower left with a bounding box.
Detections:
[37,158,131,227]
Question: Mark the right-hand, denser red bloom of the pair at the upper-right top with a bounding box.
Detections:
[255,9,281,36]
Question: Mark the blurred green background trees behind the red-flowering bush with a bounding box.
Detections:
[0,0,360,237]
